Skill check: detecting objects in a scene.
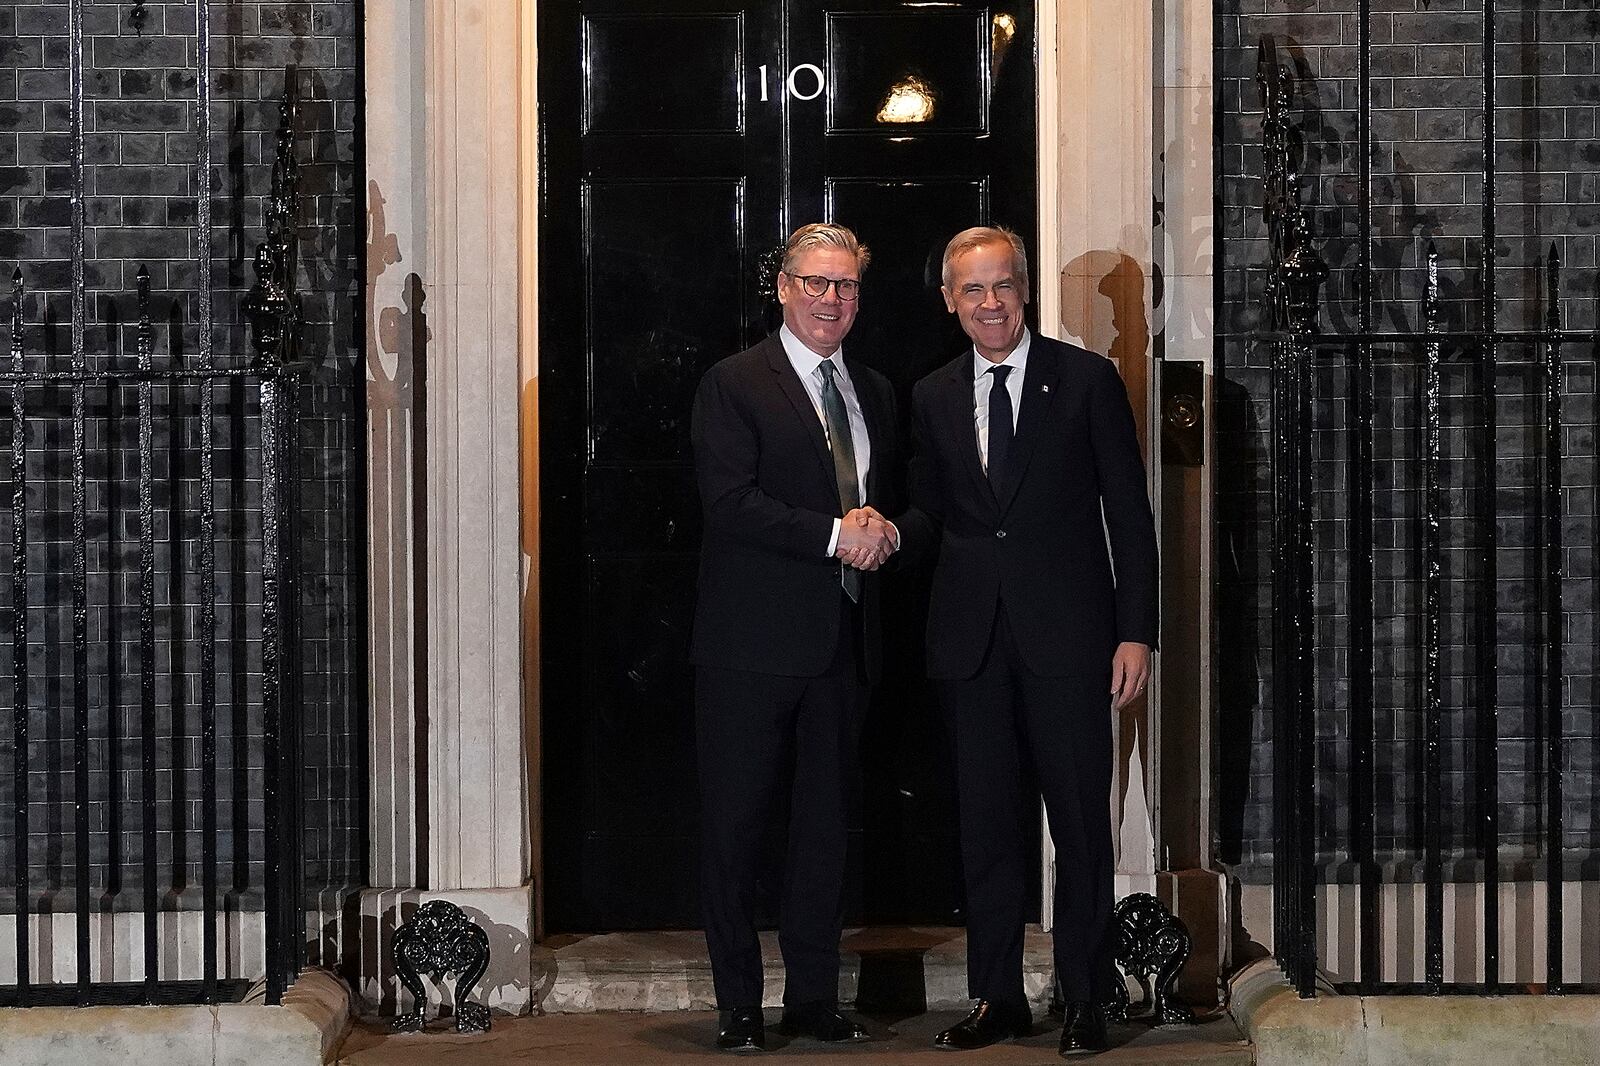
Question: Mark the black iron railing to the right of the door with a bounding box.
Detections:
[1258,24,1595,996]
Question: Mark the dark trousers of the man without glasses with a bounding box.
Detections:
[941,610,1112,1005]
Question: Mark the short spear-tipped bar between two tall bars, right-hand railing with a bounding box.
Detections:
[1422,242,1445,996]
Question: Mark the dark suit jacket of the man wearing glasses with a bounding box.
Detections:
[690,335,901,680]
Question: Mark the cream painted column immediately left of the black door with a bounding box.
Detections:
[424,0,528,888]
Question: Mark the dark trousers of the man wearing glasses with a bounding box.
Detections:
[694,594,866,1010]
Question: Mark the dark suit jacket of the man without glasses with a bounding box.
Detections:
[899,333,1158,680]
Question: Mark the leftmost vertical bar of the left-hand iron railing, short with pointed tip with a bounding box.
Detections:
[11,269,32,1007]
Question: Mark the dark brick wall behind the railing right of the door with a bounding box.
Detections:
[1216,0,1600,872]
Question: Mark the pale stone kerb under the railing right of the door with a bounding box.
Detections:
[1230,959,1600,1066]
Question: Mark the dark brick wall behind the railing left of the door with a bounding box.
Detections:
[0,0,365,906]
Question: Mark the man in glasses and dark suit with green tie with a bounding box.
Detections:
[693,224,898,1052]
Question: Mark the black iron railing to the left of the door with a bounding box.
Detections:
[0,31,307,1005]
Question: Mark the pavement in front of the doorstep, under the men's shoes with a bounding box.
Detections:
[338,1010,1251,1066]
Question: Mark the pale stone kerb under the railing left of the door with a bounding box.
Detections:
[0,970,350,1066]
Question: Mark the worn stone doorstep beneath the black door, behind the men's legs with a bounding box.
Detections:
[533,925,1053,1015]
